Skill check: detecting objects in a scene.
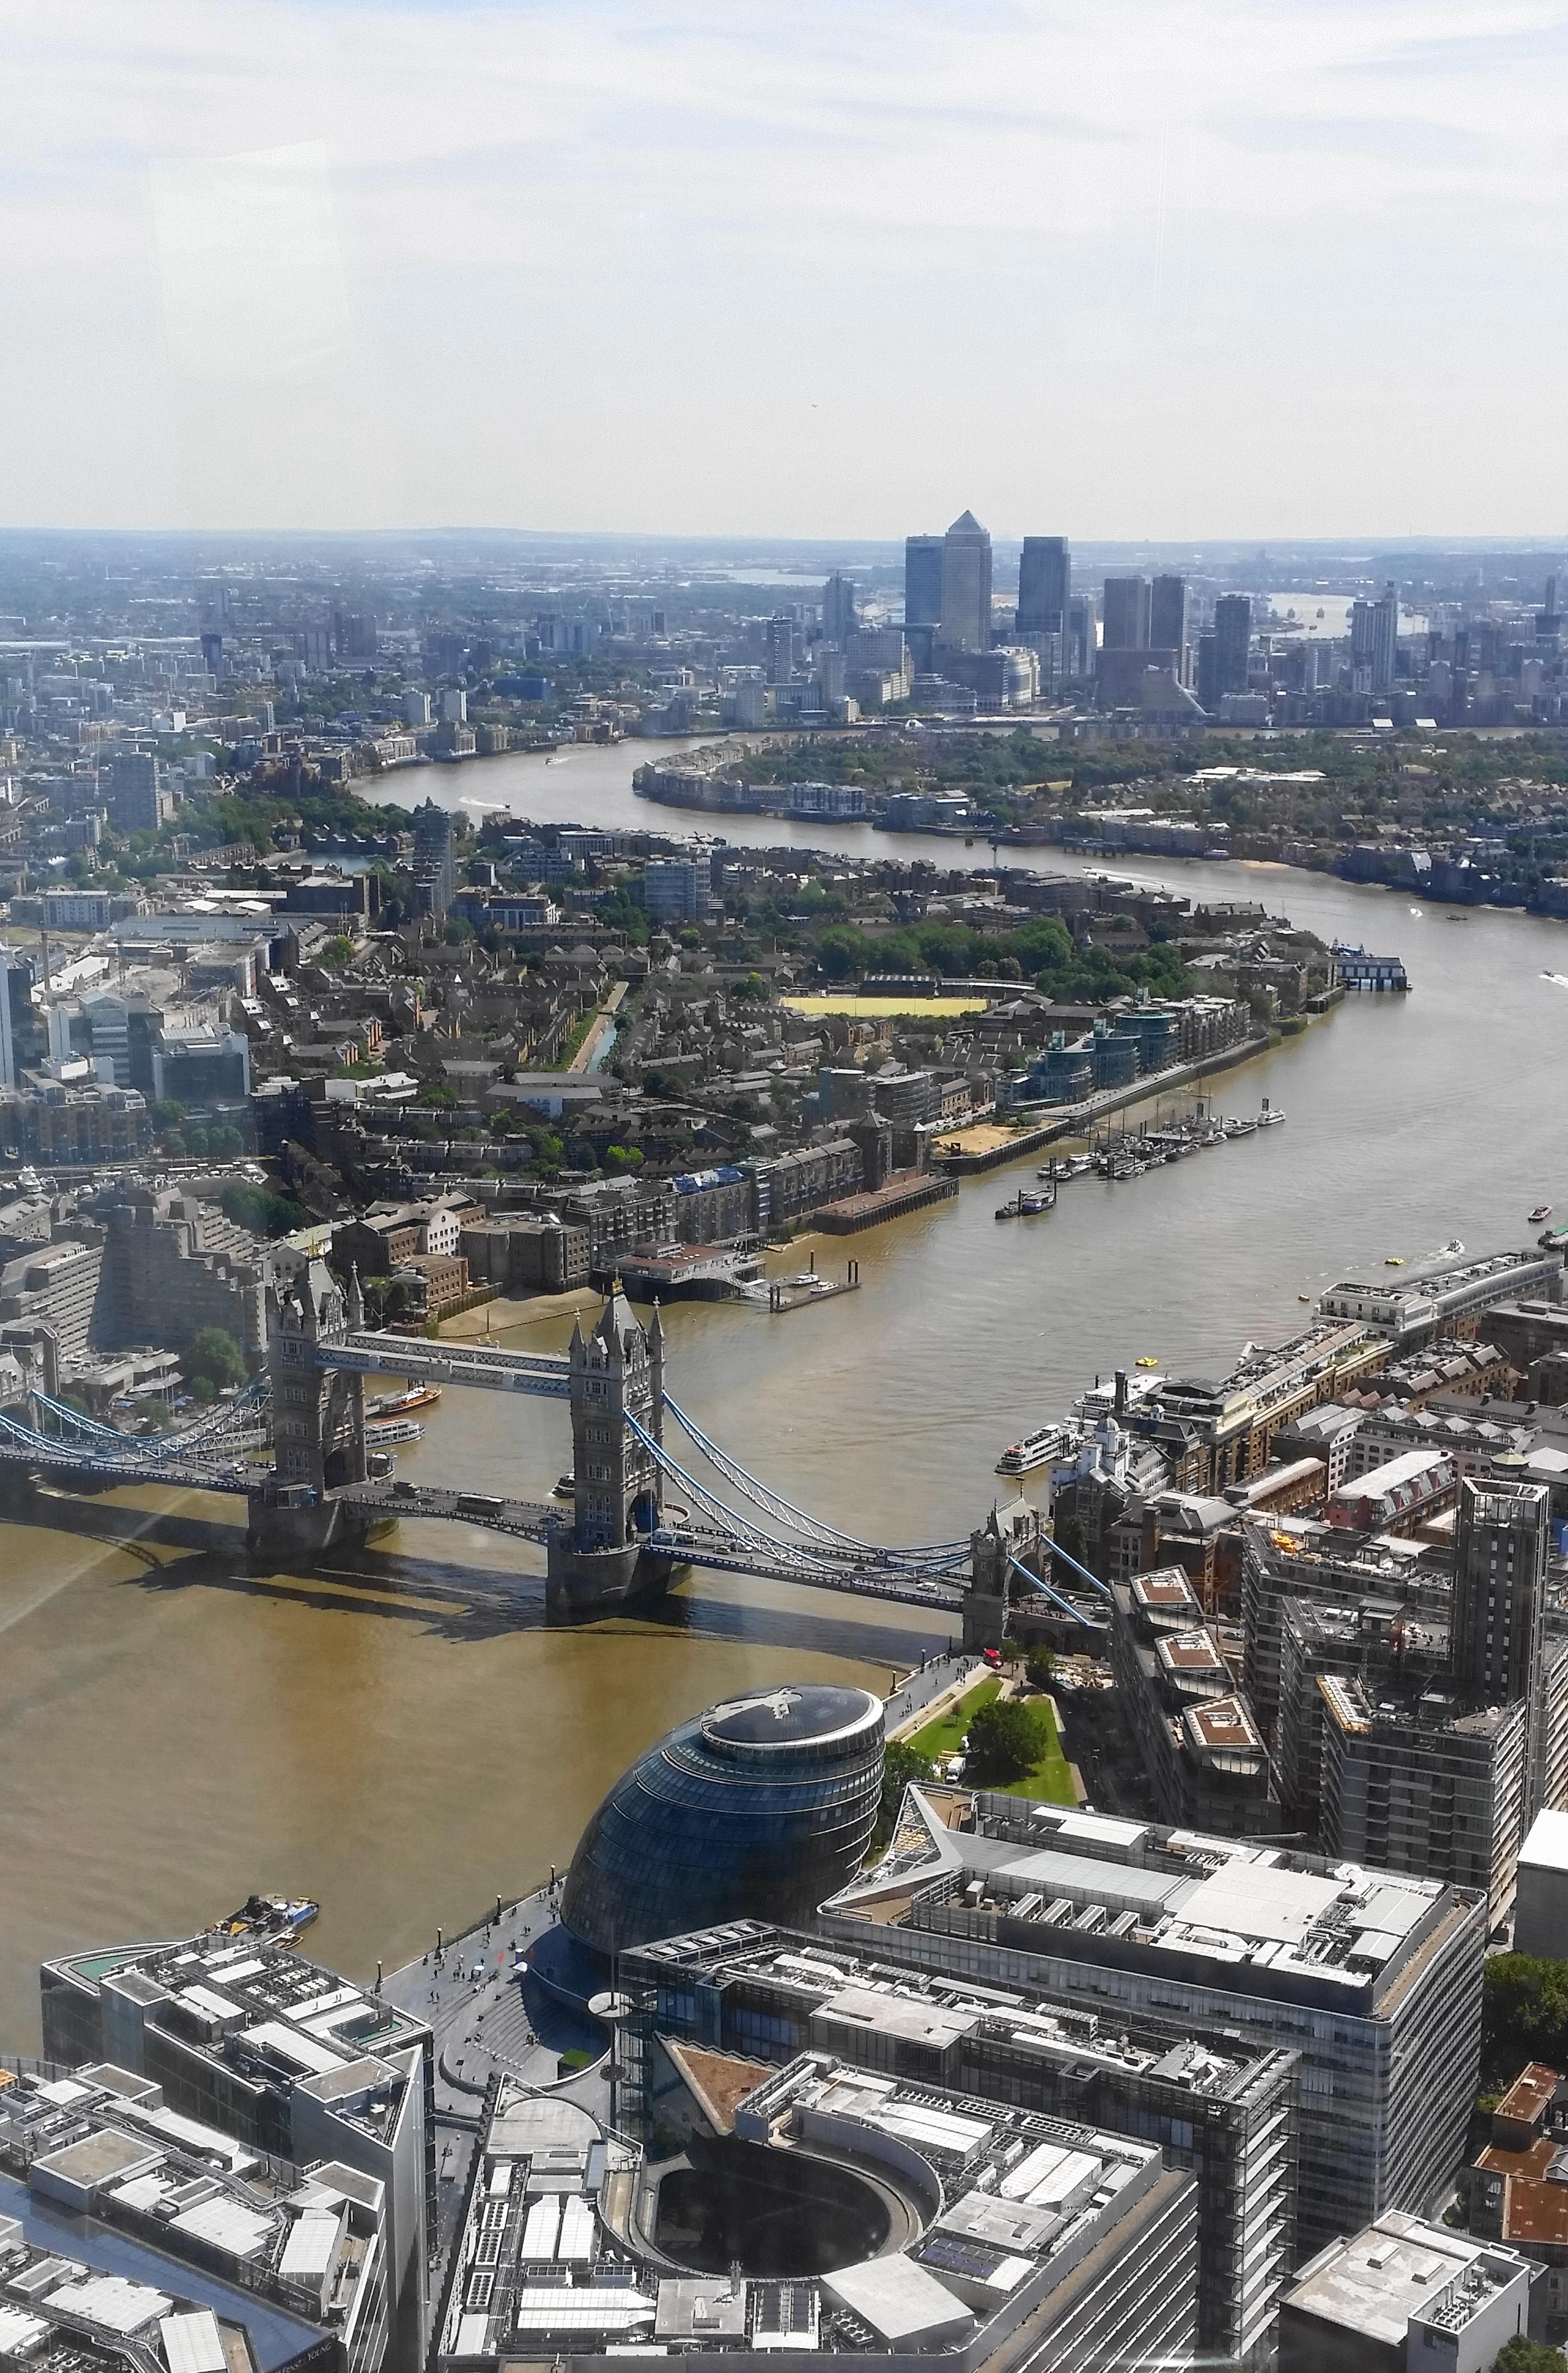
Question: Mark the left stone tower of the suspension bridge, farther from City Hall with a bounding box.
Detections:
[247,1260,368,1557]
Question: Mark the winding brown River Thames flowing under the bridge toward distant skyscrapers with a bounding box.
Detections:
[0,743,1568,2050]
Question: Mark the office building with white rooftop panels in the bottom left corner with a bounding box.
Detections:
[0,2062,391,2373]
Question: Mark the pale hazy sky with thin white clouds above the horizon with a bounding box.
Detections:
[0,0,1568,539]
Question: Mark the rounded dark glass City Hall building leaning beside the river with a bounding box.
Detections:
[560,1685,883,1953]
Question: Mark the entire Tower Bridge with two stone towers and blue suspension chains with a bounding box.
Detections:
[0,1260,1106,1644]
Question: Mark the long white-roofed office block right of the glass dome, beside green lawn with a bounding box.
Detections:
[816,1789,1485,2247]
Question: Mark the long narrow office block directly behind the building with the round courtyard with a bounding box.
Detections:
[612,1922,1298,2361]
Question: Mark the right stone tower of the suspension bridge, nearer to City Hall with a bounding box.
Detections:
[548,1281,669,1616]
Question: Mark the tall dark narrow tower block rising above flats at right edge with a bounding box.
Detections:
[1449,1479,1551,1706]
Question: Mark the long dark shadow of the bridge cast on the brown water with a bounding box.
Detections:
[0,1493,958,1666]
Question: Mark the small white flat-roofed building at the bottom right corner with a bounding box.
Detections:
[1279,2214,1535,2373]
